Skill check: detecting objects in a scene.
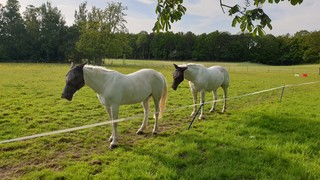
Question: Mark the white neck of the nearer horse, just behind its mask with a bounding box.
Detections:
[83,68,114,94]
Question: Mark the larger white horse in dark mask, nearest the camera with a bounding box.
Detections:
[61,64,167,149]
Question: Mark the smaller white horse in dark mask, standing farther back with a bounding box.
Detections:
[171,64,229,119]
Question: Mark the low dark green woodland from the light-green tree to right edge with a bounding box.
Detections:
[127,31,320,65]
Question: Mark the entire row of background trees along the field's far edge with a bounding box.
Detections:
[0,0,320,65]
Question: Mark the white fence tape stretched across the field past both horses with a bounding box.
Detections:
[0,81,320,144]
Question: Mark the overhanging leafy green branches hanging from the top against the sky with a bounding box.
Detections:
[153,0,303,36]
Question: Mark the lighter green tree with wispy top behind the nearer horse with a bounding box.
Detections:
[75,2,130,64]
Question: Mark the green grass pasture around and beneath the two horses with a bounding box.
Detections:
[0,60,320,179]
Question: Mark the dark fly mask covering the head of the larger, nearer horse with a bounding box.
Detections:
[61,64,85,101]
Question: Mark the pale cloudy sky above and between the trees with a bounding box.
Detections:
[0,0,320,35]
